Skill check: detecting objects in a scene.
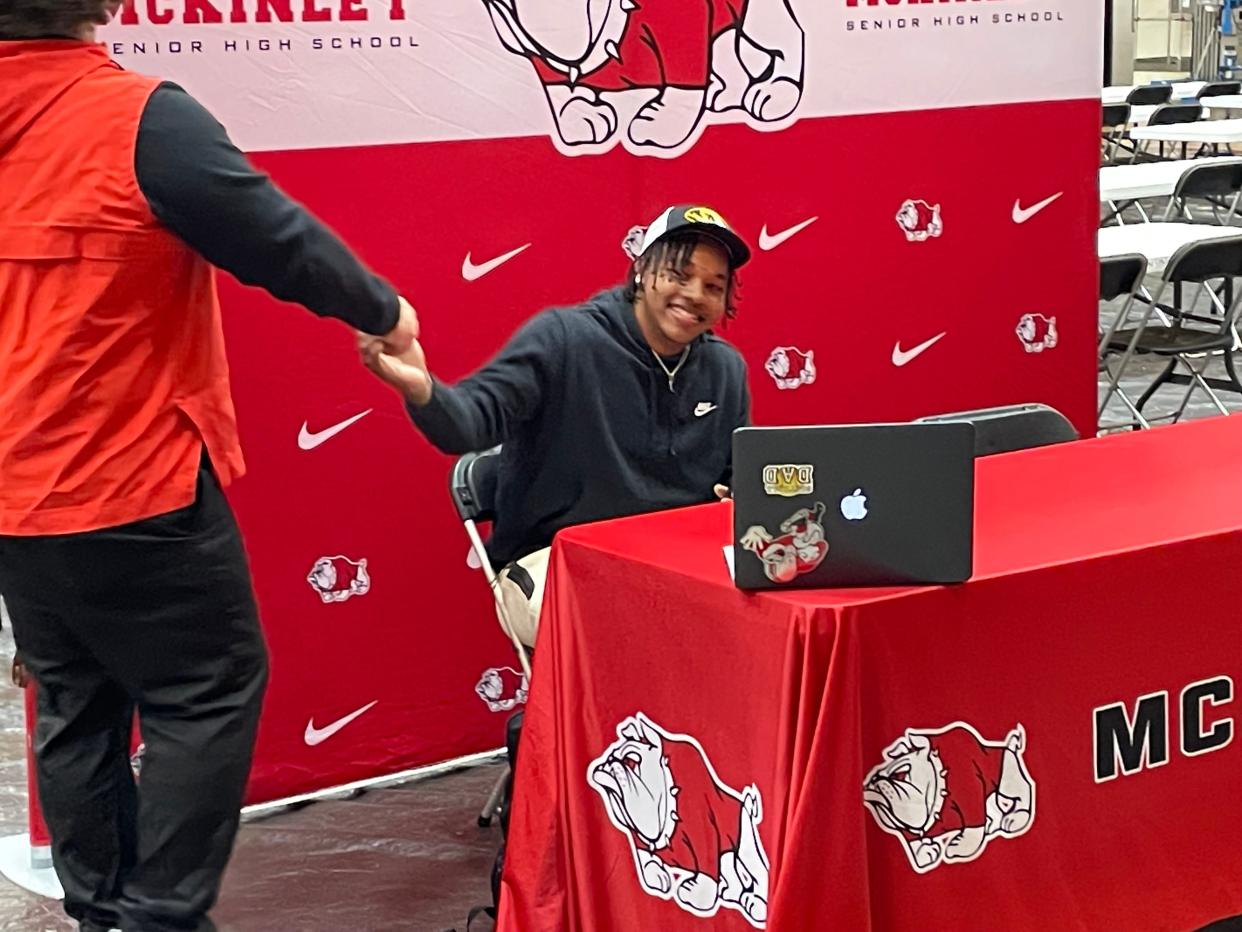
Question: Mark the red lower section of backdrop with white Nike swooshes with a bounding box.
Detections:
[211,101,1098,800]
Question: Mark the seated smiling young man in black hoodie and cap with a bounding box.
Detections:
[360,205,750,645]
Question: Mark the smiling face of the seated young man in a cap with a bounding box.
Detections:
[633,237,730,355]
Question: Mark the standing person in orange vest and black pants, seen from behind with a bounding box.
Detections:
[0,0,417,932]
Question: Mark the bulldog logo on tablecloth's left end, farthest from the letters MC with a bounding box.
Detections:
[586,712,768,928]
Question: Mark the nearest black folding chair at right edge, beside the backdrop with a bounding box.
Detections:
[1108,235,1242,423]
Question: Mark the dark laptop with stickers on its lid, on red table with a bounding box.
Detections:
[733,421,975,589]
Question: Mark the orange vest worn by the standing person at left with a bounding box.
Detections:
[0,40,245,536]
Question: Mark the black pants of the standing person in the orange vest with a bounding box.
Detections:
[0,465,267,932]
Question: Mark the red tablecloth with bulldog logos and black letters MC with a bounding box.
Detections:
[499,418,1242,932]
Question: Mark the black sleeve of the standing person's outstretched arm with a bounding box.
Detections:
[134,82,397,334]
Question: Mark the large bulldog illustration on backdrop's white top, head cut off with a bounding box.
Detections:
[483,0,805,155]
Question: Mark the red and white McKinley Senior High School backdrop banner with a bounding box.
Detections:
[87,0,1102,802]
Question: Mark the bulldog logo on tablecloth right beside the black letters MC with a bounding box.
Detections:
[863,722,1035,874]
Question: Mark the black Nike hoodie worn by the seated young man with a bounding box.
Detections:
[410,288,750,565]
